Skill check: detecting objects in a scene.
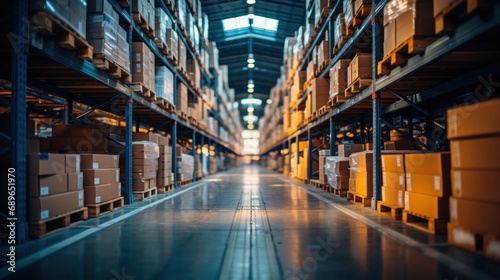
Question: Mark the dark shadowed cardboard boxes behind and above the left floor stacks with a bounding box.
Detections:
[47,124,109,154]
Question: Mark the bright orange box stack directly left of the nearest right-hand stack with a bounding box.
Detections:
[404,152,451,224]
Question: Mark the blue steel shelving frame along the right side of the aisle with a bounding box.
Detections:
[261,0,500,209]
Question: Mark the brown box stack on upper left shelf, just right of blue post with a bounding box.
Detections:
[132,42,155,91]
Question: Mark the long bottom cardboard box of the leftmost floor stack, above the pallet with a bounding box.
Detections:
[28,190,83,222]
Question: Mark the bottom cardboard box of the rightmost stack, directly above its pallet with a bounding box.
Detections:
[450,197,500,235]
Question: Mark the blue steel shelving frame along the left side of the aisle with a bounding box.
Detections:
[0,0,239,243]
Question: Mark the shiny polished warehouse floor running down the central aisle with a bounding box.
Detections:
[0,165,500,280]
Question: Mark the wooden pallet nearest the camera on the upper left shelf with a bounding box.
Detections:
[31,11,94,61]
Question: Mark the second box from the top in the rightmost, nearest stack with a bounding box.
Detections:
[450,136,500,170]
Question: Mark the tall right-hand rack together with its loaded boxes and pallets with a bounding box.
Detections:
[261,0,500,249]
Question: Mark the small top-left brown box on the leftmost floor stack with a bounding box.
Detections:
[28,153,66,175]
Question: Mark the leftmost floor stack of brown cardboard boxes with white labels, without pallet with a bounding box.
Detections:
[27,153,84,222]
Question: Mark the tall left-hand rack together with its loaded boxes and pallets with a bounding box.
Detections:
[0,0,239,242]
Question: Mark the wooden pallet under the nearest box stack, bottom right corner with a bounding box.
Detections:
[447,223,500,261]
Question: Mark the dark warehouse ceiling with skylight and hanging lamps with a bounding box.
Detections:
[201,0,306,128]
